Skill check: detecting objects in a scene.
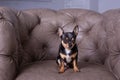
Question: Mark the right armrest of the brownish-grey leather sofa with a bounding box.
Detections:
[103,9,120,80]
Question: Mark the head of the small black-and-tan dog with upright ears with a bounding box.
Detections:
[58,25,79,49]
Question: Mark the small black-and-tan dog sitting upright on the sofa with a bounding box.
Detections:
[56,25,79,73]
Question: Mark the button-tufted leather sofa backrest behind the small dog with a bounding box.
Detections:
[0,8,108,65]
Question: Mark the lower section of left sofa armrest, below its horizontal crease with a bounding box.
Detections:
[0,55,16,80]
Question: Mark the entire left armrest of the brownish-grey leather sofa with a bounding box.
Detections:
[0,8,18,80]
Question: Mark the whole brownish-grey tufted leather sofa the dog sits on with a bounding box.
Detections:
[0,7,120,80]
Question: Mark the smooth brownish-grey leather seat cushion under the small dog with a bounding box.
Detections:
[16,60,116,80]
